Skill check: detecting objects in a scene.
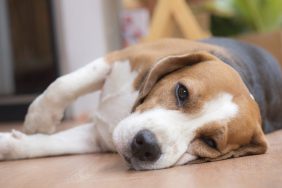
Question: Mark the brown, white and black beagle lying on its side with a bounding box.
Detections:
[0,38,282,170]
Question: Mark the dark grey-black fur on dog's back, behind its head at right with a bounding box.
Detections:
[202,38,282,133]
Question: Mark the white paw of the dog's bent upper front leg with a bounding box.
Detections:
[23,95,63,134]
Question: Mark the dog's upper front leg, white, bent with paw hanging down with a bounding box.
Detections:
[24,58,110,134]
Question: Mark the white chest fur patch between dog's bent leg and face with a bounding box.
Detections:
[94,60,138,150]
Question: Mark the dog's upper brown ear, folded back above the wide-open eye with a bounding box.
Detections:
[133,51,216,110]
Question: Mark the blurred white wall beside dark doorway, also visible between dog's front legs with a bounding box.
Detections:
[53,0,121,118]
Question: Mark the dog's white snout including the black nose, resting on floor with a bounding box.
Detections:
[113,108,187,170]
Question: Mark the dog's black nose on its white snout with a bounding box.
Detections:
[131,130,161,162]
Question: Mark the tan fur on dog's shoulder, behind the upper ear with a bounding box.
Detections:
[106,39,226,89]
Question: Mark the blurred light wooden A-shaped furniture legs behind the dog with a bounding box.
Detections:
[144,0,209,41]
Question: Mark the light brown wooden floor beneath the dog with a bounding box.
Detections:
[0,121,282,188]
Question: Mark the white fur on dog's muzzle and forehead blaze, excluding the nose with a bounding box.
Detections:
[113,93,238,169]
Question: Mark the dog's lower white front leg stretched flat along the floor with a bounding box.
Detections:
[0,124,110,160]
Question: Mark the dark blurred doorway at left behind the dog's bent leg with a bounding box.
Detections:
[0,0,58,121]
